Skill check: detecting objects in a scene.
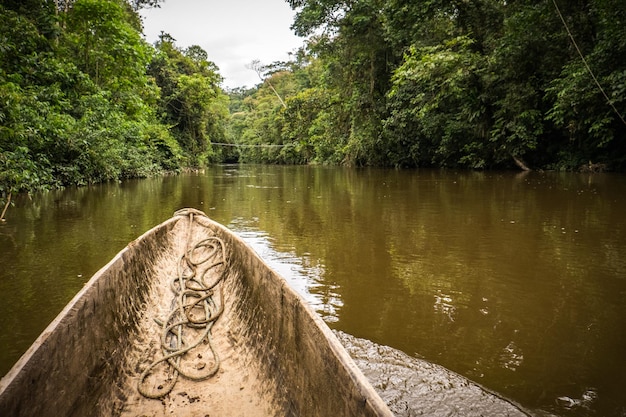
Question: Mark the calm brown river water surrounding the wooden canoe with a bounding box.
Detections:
[0,165,626,417]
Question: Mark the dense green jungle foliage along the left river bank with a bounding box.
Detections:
[0,0,228,208]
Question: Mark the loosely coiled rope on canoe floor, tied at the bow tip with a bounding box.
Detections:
[137,209,226,399]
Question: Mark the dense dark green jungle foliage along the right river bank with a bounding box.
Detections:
[231,0,626,171]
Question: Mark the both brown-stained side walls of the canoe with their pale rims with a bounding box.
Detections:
[0,211,393,417]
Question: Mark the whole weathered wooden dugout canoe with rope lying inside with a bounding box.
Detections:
[0,209,393,417]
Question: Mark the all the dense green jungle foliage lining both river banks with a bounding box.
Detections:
[0,0,626,214]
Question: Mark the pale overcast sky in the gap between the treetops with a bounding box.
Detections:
[141,0,303,88]
